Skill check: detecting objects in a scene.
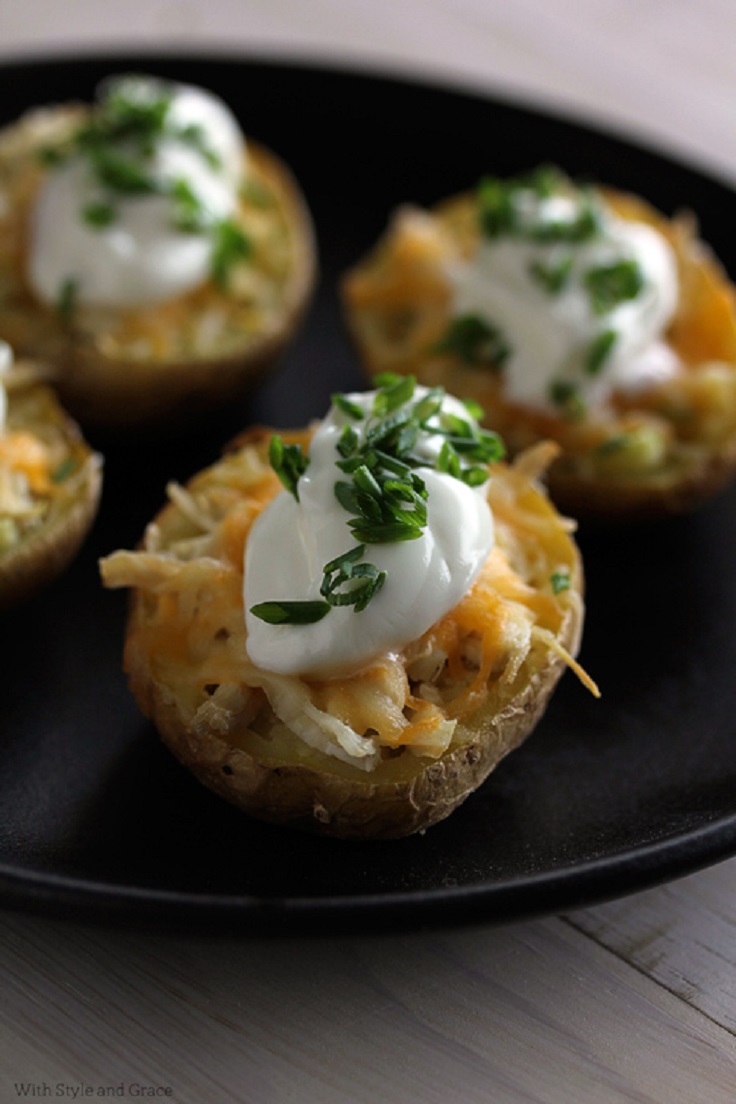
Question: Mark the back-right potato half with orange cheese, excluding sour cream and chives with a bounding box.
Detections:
[342,190,736,520]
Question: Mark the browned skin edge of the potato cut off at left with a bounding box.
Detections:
[0,386,103,609]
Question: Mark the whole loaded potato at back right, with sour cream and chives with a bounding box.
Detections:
[342,168,736,520]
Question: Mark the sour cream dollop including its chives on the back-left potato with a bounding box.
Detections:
[28,76,245,308]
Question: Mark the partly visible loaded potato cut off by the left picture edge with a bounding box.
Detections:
[0,344,102,609]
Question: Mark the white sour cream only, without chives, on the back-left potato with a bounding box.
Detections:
[28,77,245,308]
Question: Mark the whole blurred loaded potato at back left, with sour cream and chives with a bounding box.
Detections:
[0,78,317,431]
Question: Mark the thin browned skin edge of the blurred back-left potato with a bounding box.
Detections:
[0,104,318,430]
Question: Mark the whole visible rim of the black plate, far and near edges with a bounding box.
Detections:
[0,43,736,935]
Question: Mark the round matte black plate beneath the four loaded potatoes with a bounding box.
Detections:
[0,56,736,933]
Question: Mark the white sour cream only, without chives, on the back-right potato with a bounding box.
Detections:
[451,185,679,412]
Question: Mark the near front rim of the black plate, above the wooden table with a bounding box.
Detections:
[0,811,736,936]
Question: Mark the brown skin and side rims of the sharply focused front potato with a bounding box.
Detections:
[109,429,584,839]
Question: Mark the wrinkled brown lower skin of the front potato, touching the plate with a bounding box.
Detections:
[130,606,583,840]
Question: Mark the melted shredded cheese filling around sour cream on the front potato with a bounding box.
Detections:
[100,426,597,771]
